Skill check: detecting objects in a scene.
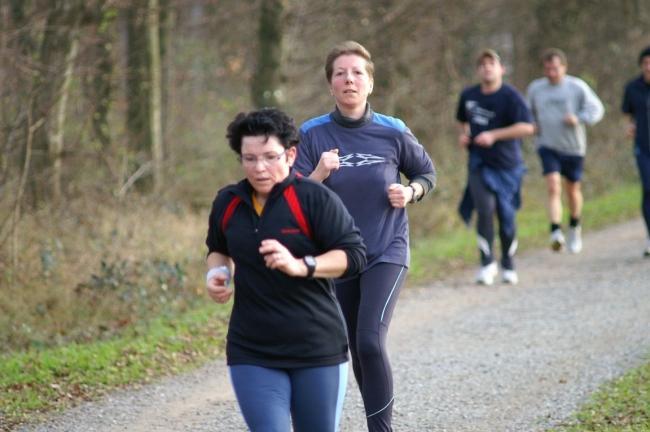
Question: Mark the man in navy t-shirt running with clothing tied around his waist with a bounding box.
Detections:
[456,49,534,285]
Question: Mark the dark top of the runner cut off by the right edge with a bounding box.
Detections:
[621,75,650,155]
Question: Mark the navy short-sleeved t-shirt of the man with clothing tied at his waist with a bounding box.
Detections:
[456,84,532,169]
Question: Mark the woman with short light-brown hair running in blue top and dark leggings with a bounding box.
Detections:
[296,41,436,432]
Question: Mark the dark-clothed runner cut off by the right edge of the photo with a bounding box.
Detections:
[623,46,650,257]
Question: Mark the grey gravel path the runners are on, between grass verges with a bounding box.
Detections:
[15,220,650,432]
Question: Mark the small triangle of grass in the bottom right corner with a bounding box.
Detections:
[553,363,650,432]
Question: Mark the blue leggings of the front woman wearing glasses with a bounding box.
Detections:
[229,362,348,432]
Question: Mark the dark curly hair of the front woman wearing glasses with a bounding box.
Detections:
[226,108,299,155]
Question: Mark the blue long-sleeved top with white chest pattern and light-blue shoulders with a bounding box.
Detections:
[294,107,435,267]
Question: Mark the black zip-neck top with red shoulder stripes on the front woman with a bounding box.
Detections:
[206,171,366,368]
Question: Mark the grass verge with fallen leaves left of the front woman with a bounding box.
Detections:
[0,302,229,430]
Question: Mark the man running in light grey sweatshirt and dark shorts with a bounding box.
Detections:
[526,48,605,253]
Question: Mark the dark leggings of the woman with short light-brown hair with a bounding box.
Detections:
[336,263,406,432]
